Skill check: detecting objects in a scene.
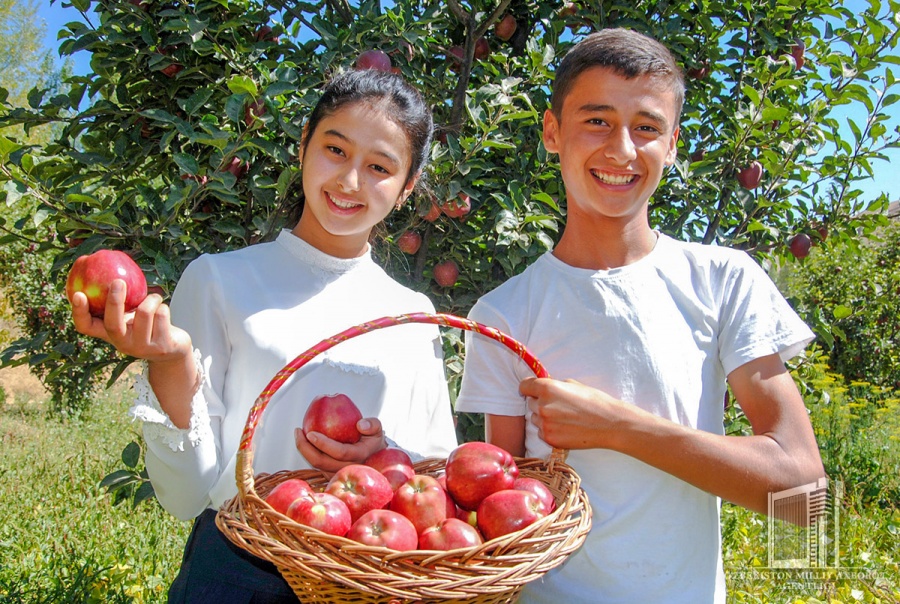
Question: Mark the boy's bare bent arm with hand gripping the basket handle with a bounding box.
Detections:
[520,354,824,513]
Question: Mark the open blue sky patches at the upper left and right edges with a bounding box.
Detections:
[38,0,900,205]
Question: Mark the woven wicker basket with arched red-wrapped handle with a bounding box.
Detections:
[216,313,591,603]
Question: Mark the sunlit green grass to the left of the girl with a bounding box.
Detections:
[0,388,190,604]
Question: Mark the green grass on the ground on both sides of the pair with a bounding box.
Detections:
[0,378,900,604]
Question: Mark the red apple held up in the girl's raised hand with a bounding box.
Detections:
[66,250,147,317]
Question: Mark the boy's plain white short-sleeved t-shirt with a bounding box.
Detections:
[456,235,813,604]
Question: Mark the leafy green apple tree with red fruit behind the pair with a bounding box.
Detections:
[0,0,900,438]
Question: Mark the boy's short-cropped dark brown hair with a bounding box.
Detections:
[550,28,685,125]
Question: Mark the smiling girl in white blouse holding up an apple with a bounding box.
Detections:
[72,70,456,604]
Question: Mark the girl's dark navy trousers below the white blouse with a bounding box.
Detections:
[169,510,298,604]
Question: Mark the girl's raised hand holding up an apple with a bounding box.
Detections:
[72,279,191,362]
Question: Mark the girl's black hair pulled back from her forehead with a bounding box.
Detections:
[302,69,434,181]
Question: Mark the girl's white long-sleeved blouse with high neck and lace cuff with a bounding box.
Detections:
[132,231,456,519]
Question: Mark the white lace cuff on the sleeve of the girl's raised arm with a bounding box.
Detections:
[130,349,213,451]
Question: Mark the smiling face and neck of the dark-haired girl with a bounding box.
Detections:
[293,103,416,258]
